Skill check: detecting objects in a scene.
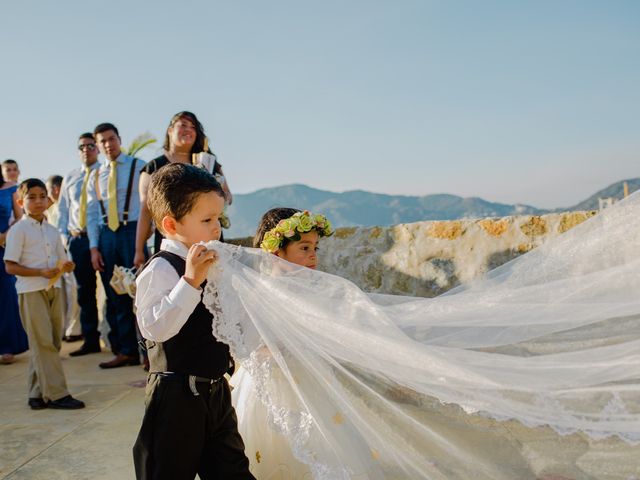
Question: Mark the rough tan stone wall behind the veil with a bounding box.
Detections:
[231,212,596,297]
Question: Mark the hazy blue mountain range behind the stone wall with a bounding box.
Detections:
[225,178,640,238]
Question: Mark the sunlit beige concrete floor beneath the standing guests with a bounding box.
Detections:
[0,342,146,480]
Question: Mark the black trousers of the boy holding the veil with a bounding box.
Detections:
[133,374,255,480]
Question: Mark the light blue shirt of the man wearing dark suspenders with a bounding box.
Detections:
[87,153,146,248]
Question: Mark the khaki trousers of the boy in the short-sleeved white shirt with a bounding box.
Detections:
[18,288,69,400]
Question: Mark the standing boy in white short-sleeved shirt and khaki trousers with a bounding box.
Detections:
[4,178,84,410]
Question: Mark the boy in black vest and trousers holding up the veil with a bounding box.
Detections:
[133,163,255,480]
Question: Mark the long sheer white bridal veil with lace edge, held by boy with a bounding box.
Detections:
[205,195,640,480]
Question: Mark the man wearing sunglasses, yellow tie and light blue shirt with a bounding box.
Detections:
[58,133,100,357]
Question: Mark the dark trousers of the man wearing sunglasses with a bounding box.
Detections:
[69,236,100,347]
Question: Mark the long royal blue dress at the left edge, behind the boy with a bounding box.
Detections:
[0,186,29,355]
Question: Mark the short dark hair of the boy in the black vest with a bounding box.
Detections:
[147,163,224,233]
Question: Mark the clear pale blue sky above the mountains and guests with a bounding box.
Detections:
[0,0,640,207]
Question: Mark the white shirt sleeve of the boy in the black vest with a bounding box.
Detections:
[136,258,202,342]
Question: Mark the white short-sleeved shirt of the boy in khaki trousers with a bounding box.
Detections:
[4,215,69,293]
